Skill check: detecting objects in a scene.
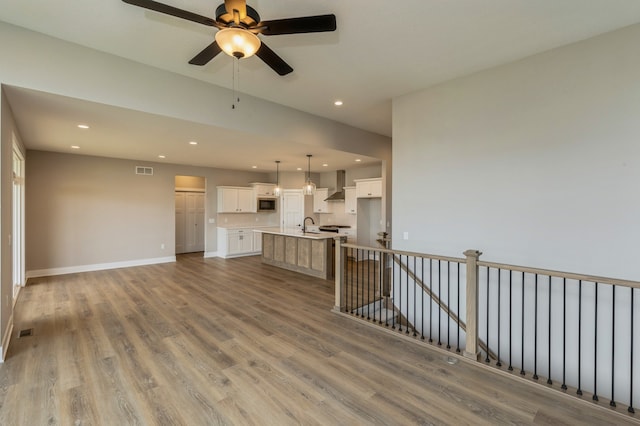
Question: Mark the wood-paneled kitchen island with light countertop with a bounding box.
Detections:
[254,228,338,280]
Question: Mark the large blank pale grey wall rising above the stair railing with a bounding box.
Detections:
[392,25,640,280]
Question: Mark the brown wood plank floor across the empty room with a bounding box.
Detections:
[0,255,637,425]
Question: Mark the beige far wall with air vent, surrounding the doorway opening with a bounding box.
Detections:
[26,151,277,276]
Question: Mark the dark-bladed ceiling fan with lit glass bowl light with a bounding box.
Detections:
[122,0,336,75]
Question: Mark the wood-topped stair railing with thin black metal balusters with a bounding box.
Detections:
[334,238,640,417]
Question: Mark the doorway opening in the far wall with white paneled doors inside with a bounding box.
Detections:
[174,176,206,257]
